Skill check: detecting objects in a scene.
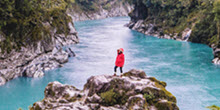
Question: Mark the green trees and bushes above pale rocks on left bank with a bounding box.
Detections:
[0,0,74,52]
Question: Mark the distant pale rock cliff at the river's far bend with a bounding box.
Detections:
[68,0,133,21]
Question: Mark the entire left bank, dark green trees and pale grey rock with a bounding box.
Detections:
[0,0,78,85]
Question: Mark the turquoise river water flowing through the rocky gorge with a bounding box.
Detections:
[0,17,220,110]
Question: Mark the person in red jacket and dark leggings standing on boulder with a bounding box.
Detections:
[114,48,125,76]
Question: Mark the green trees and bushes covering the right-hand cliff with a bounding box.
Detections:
[130,0,220,47]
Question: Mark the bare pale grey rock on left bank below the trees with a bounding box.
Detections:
[0,23,78,85]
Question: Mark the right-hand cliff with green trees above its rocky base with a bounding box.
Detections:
[126,0,220,64]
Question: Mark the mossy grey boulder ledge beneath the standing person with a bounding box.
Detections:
[30,69,179,110]
